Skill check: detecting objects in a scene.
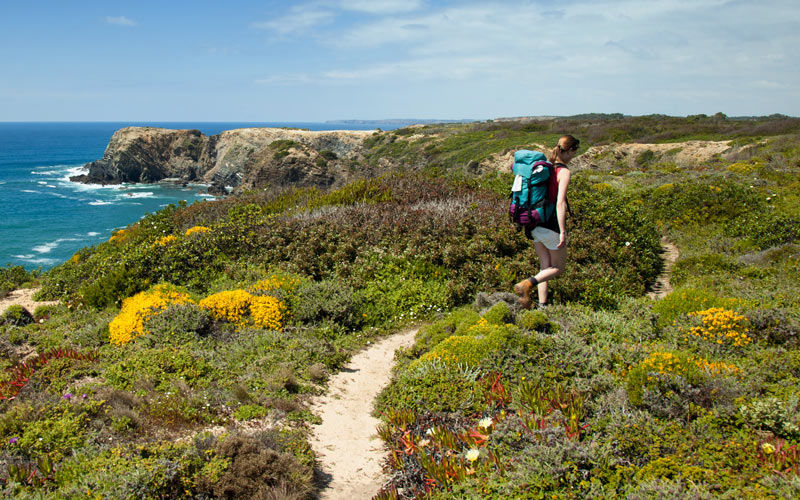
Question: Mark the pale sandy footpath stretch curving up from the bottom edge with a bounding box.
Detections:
[311,330,417,500]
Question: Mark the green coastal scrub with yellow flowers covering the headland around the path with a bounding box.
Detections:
[0,115,800,498]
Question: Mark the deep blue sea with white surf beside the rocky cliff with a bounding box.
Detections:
[0,122,402,270]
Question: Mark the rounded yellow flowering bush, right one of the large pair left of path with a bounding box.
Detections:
[198,290,286,330]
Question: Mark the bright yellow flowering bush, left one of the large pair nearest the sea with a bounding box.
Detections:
[108,283,192,344]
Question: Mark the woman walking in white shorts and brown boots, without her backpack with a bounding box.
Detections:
[514,135,580,309]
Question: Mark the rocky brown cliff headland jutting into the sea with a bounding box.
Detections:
[71,127,372,192]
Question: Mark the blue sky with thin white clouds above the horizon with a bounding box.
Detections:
[0,0,800,121]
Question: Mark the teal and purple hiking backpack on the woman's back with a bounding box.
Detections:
[508,149,556,234]
